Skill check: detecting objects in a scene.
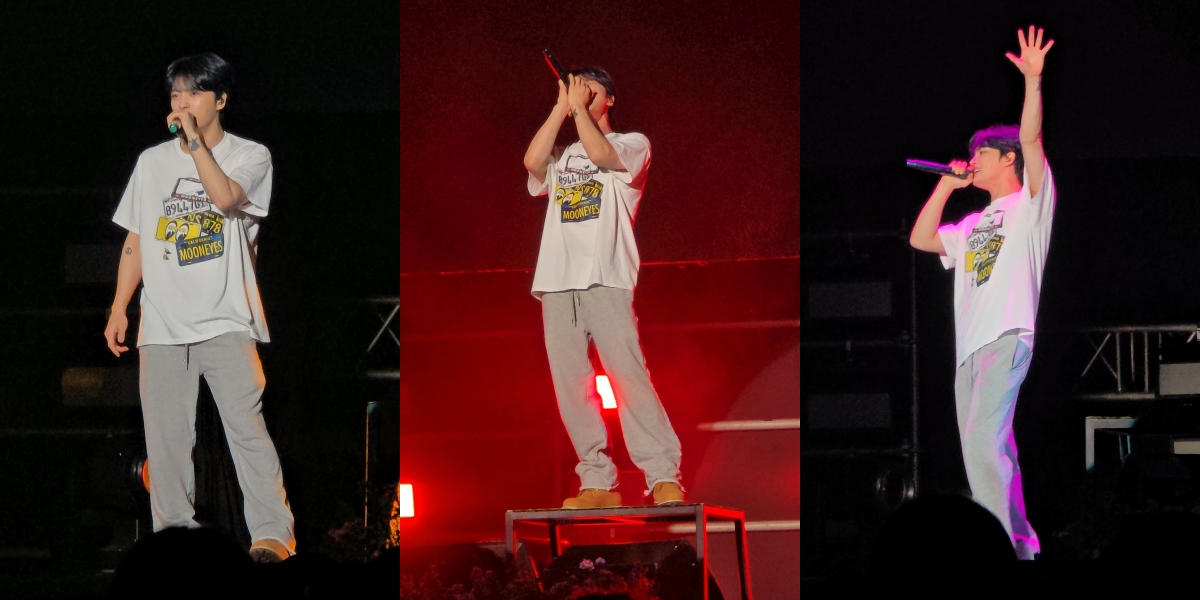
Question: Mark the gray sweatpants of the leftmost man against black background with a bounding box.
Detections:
[138,331,295,552]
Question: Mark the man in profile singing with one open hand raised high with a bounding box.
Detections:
[910,26,1056,559]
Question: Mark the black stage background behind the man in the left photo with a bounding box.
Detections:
[0,0,400,590]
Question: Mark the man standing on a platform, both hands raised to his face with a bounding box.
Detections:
[524,67,683,509]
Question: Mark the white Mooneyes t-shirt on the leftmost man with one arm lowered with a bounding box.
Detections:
[113,132,274,347]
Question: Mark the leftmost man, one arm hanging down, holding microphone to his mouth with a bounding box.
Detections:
[104,53,295,562]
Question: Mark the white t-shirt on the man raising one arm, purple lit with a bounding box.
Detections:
[937,162,1056,366]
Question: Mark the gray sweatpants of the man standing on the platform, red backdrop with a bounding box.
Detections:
[541,286,680,490]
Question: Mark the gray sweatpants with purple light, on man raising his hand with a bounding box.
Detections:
[954,330,1040,559]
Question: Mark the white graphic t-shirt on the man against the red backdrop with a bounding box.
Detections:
[528,132,650,299]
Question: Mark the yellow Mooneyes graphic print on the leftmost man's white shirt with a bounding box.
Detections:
[155,178,224,266]
